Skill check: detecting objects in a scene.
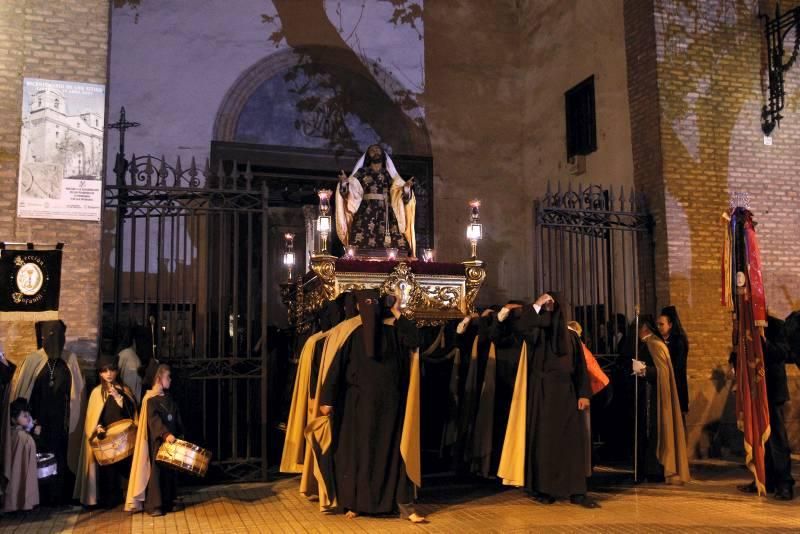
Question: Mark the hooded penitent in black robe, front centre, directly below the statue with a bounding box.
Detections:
[312,290,420,514]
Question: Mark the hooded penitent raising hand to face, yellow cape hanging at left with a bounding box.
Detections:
[498,292,591,497]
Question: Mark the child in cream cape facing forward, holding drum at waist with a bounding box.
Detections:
[73,354,138,508]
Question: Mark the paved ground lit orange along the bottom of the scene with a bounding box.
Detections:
[0,462,800,534]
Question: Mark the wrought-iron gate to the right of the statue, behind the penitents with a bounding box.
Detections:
[535,184,655,466]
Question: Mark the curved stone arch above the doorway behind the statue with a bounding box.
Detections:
[213,46,431,156]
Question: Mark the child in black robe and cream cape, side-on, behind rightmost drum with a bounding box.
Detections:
[125,363,183,516]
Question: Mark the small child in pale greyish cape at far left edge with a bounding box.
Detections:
[3,397,41,512]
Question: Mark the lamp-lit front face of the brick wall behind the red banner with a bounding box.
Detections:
[655,0,800,369]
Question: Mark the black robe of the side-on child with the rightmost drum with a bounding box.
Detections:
[144,394,183,512]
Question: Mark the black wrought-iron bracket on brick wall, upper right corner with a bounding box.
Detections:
[760,2,800,135]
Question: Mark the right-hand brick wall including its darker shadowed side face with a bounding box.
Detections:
[625,0,800,455]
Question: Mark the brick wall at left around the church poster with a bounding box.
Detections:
[0,0,109,360]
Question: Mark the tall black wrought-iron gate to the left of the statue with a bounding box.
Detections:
[103,156,268,480]
